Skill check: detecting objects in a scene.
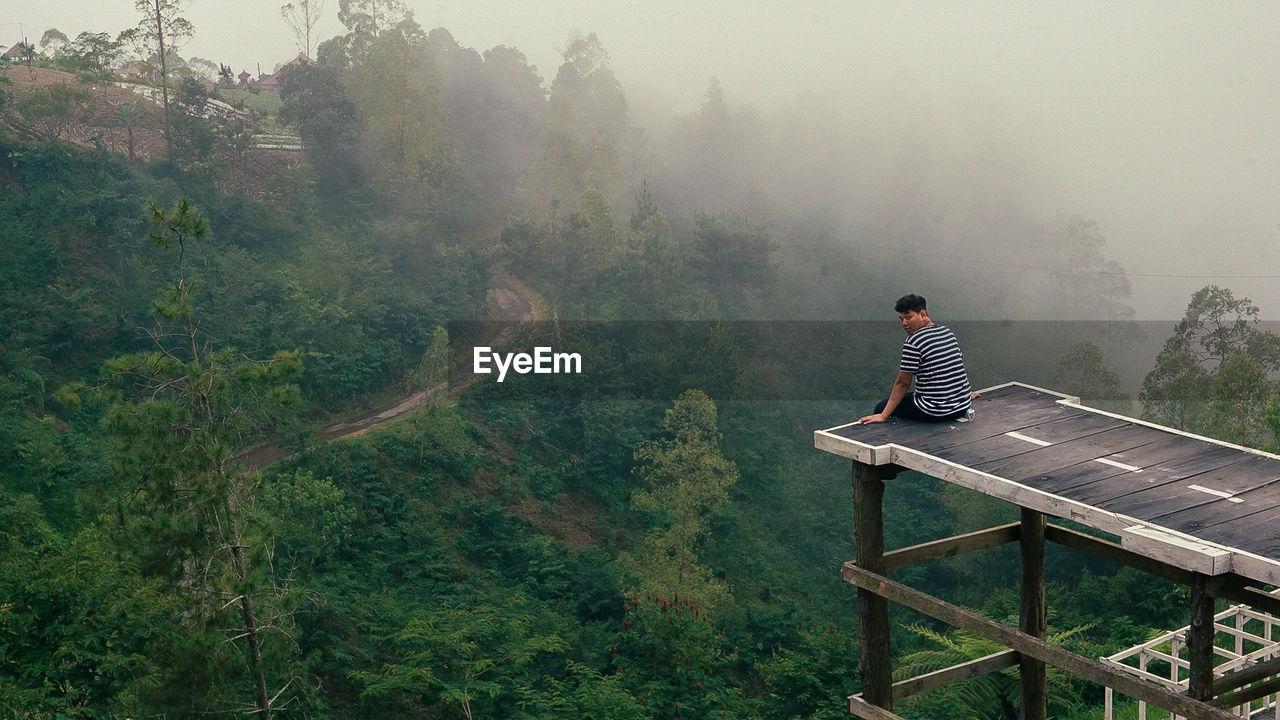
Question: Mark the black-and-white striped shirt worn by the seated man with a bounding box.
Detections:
[897,324,970,416]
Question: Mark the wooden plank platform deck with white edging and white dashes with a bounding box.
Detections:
[814,383,1280,584]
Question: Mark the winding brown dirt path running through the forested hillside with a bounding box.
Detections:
[241,277,535,470]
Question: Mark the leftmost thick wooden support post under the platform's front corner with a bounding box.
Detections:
[854,460,893,710]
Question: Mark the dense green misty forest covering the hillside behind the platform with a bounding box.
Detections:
[0,0,1280,720]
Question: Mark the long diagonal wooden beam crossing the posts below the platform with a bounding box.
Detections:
[841,562,1239,720]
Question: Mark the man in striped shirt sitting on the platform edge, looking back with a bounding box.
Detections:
[858,295,973,423]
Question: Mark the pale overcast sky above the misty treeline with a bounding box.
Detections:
[0,0,1280,319]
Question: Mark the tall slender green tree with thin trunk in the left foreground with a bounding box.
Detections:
[94,199,302,719]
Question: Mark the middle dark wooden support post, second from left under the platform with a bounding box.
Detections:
[1018,507,1048,720]
